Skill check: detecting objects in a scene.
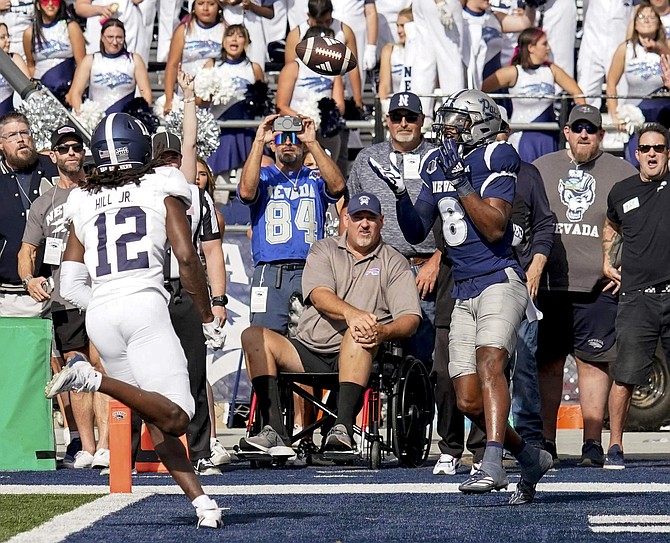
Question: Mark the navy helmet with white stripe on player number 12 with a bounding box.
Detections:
[91,113,151,173]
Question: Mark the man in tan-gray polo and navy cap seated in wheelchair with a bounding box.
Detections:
[240,192,421,456]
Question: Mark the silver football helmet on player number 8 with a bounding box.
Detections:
[433,89,503,147]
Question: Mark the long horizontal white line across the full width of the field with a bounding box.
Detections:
[0,483,670,499]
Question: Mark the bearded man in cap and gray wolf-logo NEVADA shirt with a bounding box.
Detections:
[533,104,637,466]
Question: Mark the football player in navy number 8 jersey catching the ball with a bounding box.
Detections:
[370,90,552,504]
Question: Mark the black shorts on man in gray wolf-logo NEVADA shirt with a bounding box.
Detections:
[536,292,617,363]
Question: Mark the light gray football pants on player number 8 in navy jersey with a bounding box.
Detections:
[449,268,528,379]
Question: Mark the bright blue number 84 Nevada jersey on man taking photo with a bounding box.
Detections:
[238,164,337,266]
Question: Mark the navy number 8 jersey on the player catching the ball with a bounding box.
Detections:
[398,142,525,300]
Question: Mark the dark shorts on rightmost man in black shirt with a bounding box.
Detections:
[610,290,670,385]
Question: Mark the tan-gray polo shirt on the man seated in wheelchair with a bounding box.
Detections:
[297,233,421,353]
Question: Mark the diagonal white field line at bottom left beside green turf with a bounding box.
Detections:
[7,496,147,543]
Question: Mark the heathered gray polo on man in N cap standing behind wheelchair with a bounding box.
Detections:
[347,140,435,258]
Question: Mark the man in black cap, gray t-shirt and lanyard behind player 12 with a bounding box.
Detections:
[18,123,109,469]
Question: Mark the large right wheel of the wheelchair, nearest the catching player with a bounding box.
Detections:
[391,356,434,468]
